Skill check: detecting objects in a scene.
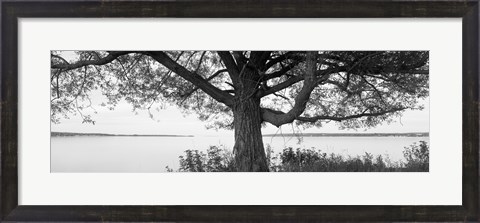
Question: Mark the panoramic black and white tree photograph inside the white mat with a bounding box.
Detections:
[50,50,430,174]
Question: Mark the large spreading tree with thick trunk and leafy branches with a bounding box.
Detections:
[51,51,429,171]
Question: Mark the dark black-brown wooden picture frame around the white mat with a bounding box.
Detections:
[0,0,480,222]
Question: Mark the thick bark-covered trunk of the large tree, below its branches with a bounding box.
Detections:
[233,97,268,172]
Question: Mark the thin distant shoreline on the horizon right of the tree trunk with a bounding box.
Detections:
[263,132,429,137]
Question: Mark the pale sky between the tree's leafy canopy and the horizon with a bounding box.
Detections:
[51,91,429,136]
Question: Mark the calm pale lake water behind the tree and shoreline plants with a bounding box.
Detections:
[51,136,428,173]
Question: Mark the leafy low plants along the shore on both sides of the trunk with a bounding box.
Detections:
[167,141,429,172]
